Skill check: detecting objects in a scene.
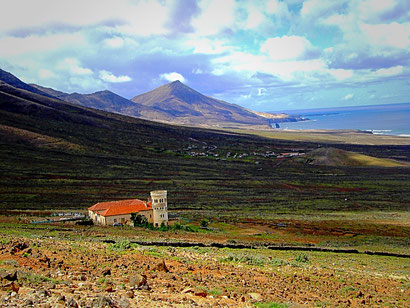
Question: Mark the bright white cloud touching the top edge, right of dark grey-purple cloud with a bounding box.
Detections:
[192,0,235,36]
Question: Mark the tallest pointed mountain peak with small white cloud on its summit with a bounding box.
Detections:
[131,81,268,126]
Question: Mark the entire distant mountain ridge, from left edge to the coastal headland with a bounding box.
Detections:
[0,70,294,129]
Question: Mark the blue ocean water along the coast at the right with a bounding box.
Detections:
[272,103,410,137]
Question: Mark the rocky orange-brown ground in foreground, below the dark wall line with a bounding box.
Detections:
[0,235,410,307]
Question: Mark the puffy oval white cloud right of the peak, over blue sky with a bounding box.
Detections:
[260,35,313,60]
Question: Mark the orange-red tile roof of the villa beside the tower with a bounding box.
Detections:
[88,199,152,216]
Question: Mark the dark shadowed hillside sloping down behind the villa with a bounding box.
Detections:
[0,67,410,213]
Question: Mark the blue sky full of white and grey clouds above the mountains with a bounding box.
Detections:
[0,0,410,111]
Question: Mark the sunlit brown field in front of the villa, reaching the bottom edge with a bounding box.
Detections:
[0,211,410,307]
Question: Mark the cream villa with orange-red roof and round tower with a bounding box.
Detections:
[88,190,168,227]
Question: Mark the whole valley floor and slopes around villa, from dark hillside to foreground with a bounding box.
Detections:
[0,68,410,307]
